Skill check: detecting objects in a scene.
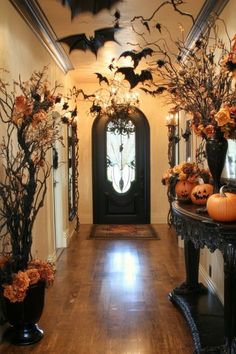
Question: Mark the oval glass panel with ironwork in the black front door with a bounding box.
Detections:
[106,121,136,193]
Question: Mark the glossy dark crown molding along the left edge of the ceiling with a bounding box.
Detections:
[10,0,74,74]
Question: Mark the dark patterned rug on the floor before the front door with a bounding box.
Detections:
[89,224,160,240]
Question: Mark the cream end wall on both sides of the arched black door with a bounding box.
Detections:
[78,85,169,224]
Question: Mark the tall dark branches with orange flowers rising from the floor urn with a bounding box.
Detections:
[0,67,76,302]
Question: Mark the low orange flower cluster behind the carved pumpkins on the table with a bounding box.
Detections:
[161,161,211,186]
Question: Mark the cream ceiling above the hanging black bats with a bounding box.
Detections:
[33,0,210,84]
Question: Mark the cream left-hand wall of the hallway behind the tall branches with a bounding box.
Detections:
[0,0,73,260]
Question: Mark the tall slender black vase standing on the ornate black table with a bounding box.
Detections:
[206,132,228,193]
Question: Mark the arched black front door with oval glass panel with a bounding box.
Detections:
[92,108,150,224]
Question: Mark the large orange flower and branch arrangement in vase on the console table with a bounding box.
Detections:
[129,16,236,139]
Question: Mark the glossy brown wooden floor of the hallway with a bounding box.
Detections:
[0,225,193,354]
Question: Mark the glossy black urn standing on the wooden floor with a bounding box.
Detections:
[4,282,45,345]
